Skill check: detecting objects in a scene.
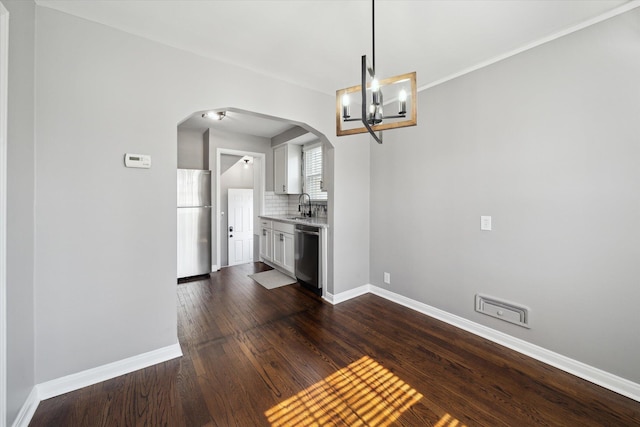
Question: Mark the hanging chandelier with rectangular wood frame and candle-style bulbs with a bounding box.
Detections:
[336,0,418,144]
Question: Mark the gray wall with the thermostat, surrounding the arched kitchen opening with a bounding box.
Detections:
[35,7,368,383]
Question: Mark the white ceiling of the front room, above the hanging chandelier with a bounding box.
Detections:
[36,0,637,135]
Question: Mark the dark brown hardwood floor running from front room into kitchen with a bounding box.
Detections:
[30,263,640,427]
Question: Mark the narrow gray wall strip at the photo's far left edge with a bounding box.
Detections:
[2,0,35,425]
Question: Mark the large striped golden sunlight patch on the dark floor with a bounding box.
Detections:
[265,356,424,427]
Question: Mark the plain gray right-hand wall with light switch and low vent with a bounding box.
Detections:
[370,11,640,382]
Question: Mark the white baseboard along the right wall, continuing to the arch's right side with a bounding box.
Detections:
[325,285,640,402]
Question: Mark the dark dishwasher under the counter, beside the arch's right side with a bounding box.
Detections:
[295,224,322,295]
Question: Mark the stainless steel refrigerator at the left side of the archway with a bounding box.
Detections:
[178,169,211,279]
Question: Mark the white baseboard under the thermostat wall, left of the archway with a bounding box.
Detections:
[36,343,182,400]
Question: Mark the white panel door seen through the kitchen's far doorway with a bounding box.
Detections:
[227,188,253,265]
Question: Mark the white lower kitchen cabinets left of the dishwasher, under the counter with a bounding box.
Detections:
[260,220,295,274]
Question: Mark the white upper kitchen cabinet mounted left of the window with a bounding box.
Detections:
[273,144,302,194]
